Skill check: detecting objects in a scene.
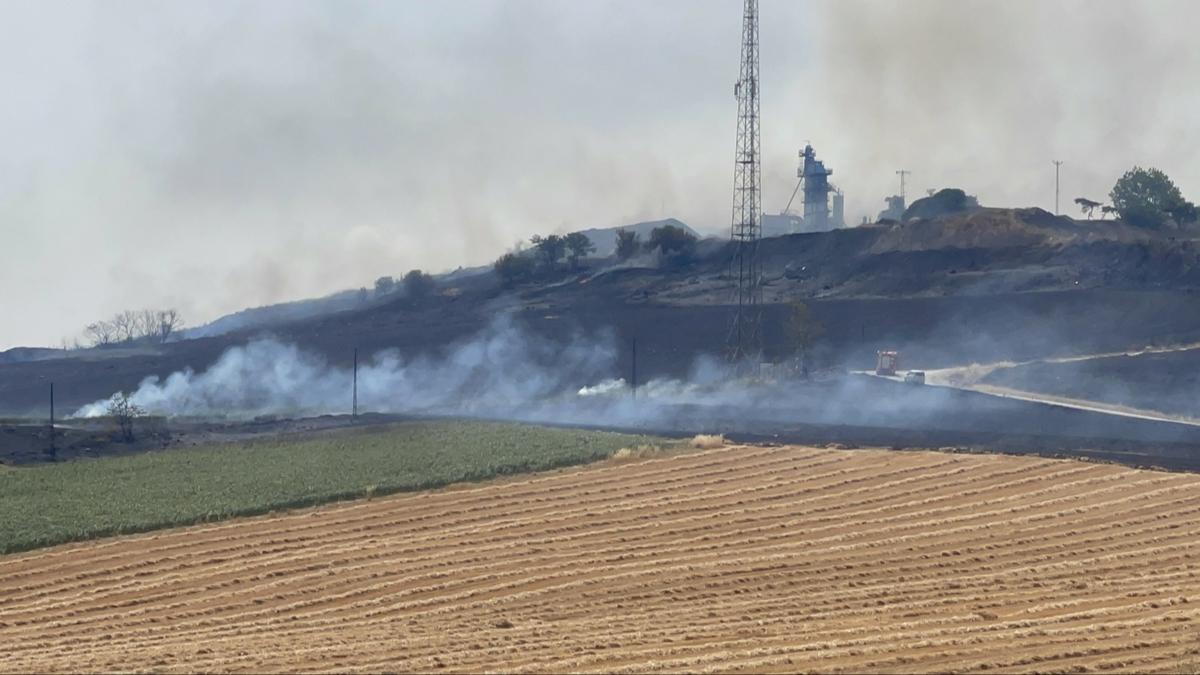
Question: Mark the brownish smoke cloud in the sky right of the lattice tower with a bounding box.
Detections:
[806,0,1200,216]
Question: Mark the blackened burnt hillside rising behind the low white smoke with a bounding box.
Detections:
[0,209,1200,432]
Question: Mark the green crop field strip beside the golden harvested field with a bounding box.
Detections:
[0,420,658,552]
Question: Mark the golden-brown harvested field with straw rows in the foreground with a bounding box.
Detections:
[0,447,1200,673]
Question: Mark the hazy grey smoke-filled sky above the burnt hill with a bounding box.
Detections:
[0,0,1200,350]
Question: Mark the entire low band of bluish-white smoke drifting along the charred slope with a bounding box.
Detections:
[76,318,1194,444]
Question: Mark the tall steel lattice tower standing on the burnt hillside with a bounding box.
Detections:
[728,0,762,362]
